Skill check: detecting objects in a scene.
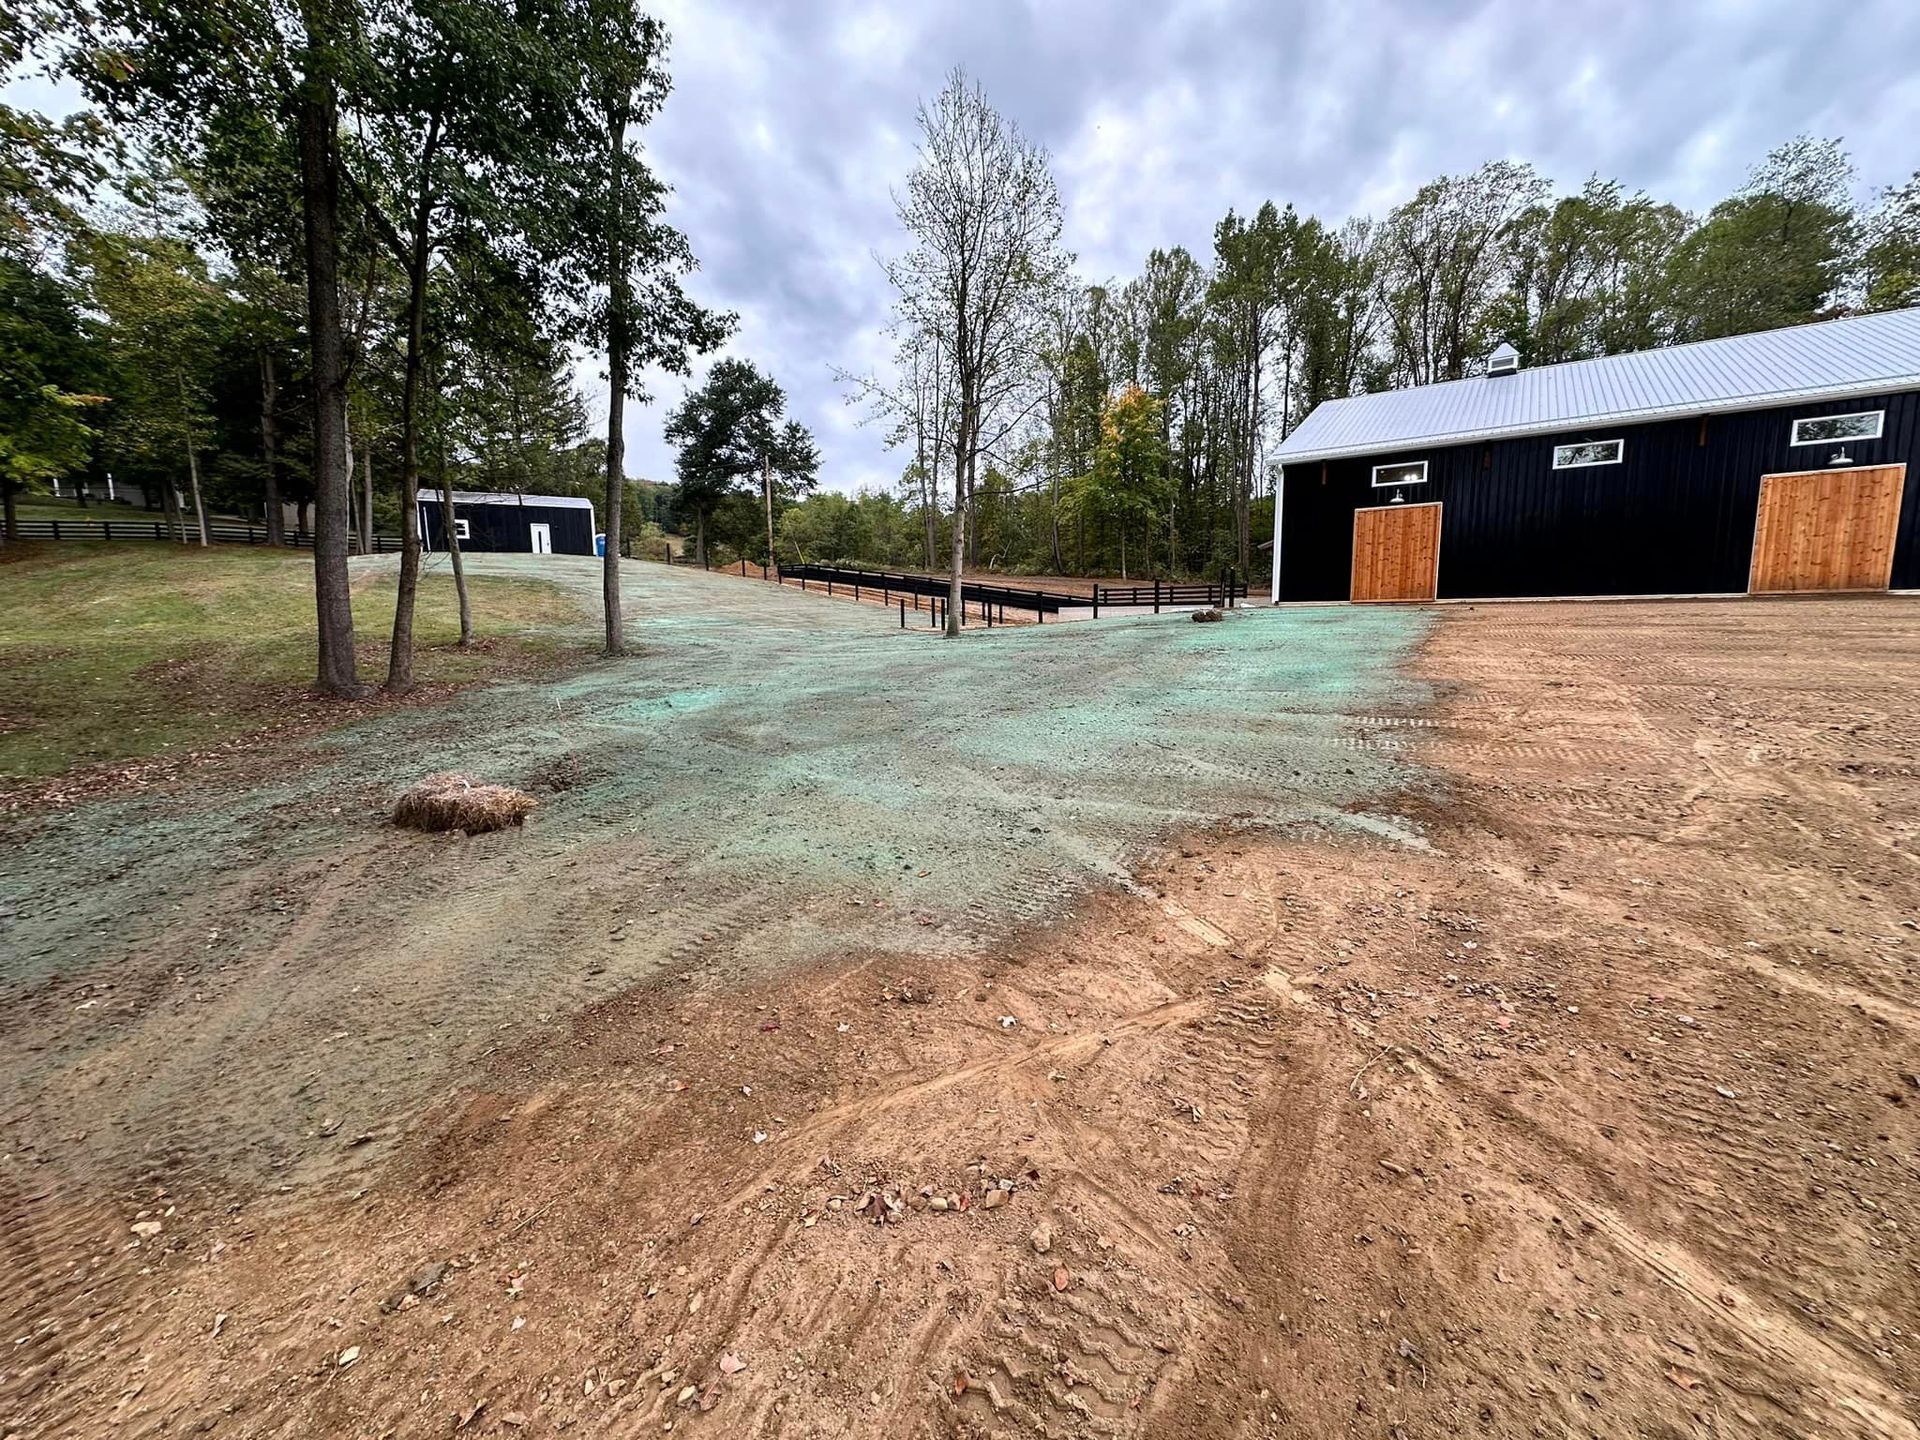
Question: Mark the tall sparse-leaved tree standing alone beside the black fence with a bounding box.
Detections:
[887,69,1069,636]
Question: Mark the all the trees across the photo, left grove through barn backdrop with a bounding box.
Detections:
[11,36,1920,660]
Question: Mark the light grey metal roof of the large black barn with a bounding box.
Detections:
[1275,309,1920,465]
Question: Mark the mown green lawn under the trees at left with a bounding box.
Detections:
[0,541,591,783]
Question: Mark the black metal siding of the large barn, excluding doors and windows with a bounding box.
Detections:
[1281,380,1920,601]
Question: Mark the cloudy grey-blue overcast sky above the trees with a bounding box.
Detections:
[12,0,1920,490]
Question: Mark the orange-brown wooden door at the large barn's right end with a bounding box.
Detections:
[1747,465,1907,595]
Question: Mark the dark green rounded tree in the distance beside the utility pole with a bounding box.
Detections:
[666,359,820,564]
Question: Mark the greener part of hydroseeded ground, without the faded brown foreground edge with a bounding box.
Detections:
[0,555,1427,979]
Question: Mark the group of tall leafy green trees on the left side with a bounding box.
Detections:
[0,0,733,695]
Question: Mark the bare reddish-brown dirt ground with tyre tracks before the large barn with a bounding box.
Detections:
[0,599,1920,1436]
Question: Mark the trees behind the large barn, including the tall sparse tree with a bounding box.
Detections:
[817,71,1920,612]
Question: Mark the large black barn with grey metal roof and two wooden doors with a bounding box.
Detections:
[1273,309,1920,601]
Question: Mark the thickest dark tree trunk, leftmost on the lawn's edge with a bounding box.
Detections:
[298,22,363,695]
